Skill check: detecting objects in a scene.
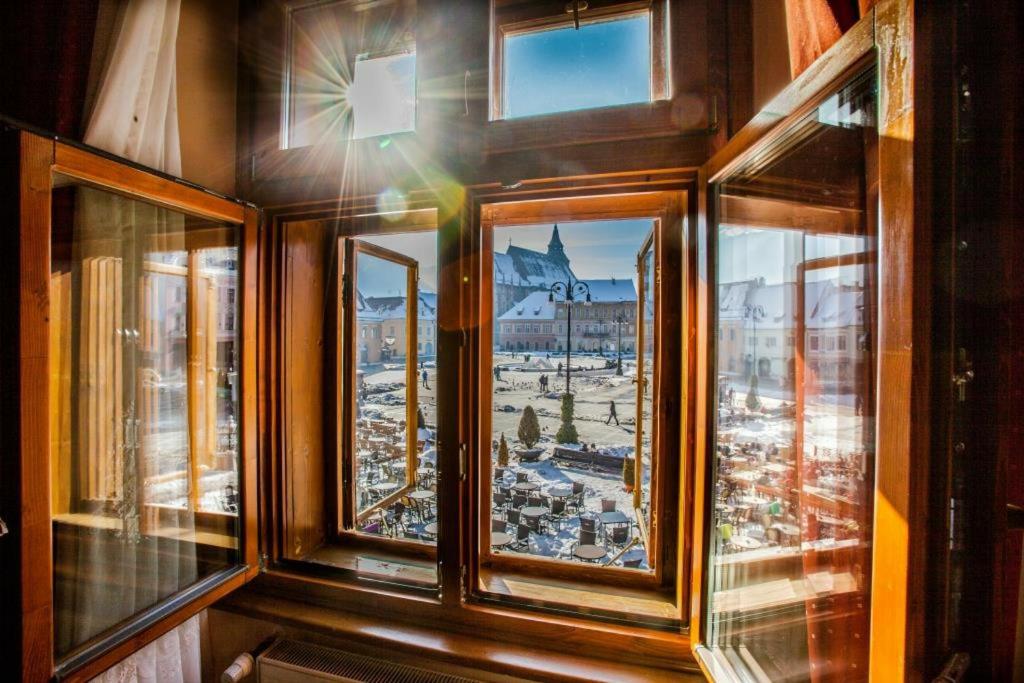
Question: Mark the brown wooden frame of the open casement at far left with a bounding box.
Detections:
[9,131,259,681]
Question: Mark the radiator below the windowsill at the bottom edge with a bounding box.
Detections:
[256,640,487,683]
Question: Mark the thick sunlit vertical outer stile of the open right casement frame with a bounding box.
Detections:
[869,0,930,680]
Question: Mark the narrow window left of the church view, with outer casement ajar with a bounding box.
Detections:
[282,209,443,589]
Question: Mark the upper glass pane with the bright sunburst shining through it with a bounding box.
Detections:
[288,0,416,147]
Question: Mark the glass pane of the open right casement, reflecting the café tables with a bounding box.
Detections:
[708,72,878,681]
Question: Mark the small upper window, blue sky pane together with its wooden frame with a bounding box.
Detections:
[492,3,668,119]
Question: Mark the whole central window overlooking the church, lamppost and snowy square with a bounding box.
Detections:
[478,194,682,622]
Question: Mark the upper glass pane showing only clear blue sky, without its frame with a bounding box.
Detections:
[502,12,651,119]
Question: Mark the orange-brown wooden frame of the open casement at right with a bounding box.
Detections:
[690,0,930,681]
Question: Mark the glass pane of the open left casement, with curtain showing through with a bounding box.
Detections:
[50,176,240,656]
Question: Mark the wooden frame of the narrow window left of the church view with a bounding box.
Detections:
[274,201,444,573]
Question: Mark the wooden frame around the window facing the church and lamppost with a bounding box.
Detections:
[467,190,691,625]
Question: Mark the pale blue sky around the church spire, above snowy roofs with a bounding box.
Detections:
[495,219,654,284]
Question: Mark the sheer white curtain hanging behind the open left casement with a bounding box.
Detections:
[58,0,202,683]
